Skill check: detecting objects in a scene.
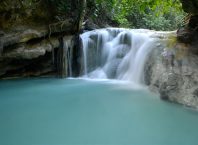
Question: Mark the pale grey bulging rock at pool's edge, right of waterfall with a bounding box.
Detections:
[145,48,198,108]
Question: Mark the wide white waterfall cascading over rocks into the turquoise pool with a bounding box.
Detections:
[81,28,174,84]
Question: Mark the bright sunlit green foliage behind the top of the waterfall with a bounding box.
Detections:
[91,0,185,30]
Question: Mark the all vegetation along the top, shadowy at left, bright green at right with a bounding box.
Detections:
[0,0,186,30]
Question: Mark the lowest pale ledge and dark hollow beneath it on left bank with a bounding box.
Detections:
[0,35,73,78]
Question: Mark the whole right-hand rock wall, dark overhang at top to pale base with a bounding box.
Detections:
[150,0,198,108]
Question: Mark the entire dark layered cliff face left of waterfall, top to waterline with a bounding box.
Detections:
[0,0,78,78]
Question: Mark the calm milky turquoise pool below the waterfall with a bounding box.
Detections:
[0,78,198,145]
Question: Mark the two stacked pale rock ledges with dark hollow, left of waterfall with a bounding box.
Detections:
[0,27,74,78]
